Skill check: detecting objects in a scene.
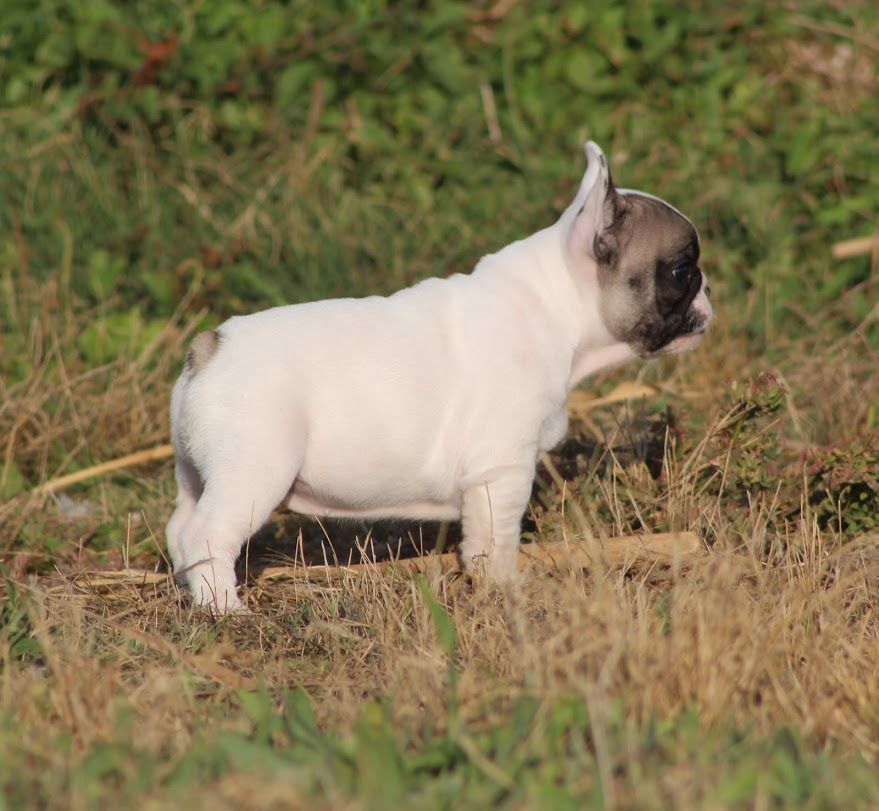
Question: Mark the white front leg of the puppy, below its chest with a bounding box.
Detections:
[460,465,534,582]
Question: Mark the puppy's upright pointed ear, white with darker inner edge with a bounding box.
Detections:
[566,141,624,265]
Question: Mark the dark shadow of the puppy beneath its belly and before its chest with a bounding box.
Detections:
[230,422,673,578]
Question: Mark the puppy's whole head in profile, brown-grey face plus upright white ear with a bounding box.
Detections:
[563,141,712,357]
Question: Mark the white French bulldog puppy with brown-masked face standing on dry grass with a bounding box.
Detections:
[167,142,712,612]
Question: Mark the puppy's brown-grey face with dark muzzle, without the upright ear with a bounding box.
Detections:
[595,192,712,357]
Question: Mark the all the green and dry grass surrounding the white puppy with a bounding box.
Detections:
[0,0,879,809]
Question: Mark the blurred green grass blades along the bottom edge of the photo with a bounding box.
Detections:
[2,691,877,809]
